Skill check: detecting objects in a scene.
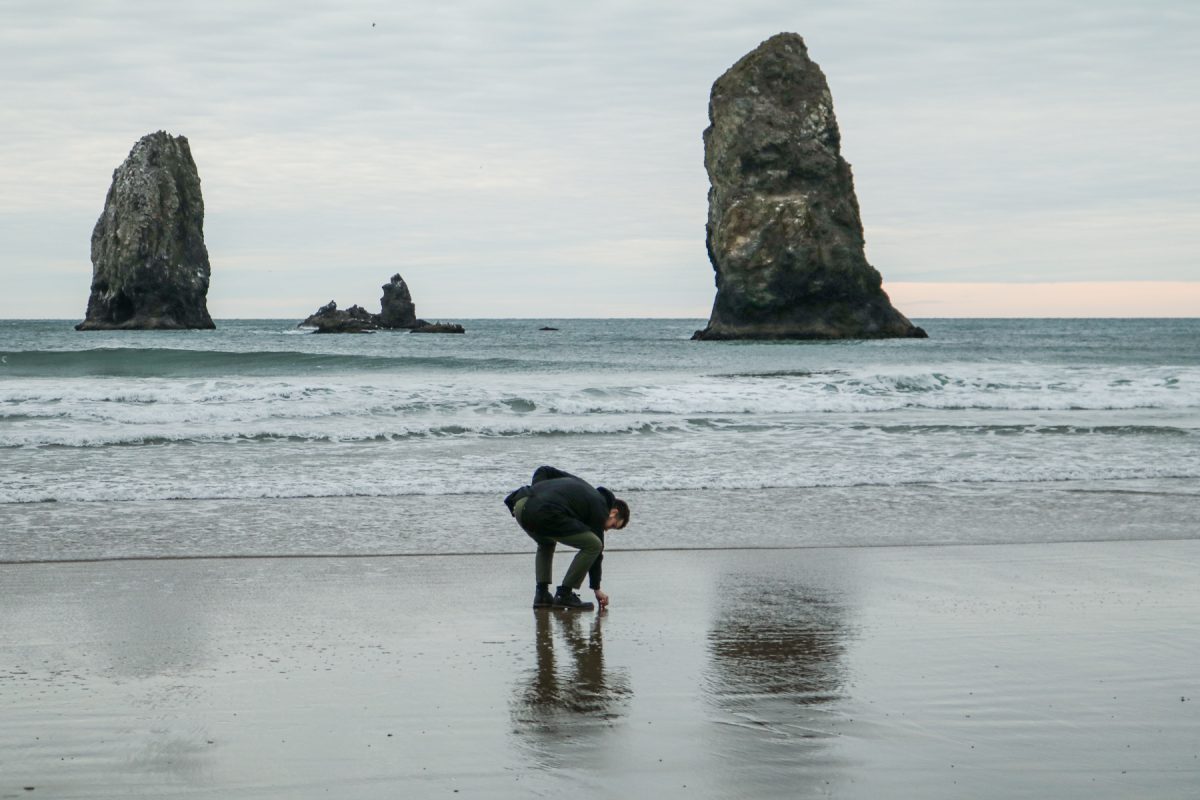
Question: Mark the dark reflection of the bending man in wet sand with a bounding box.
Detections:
[512,608,630,766]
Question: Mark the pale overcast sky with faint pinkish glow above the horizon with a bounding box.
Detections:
[0,0,1200,319]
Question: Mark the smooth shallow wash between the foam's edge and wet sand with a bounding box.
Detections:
[0,479,1200,564]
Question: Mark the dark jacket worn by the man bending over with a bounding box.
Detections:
[504,467,616,589]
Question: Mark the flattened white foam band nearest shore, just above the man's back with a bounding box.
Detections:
[0,411,1200,503]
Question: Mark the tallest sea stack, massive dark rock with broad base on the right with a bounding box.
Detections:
[692,34,925,339]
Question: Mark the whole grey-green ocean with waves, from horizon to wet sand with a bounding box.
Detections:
[0,319,1200,563]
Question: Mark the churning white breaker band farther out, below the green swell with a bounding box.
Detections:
[0,367,1200,447]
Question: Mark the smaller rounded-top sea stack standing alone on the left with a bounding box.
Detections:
[76,131,215,331]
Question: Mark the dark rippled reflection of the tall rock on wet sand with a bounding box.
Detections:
[706,575,847,796]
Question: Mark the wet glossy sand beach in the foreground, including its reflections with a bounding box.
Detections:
[0,540,1200,799]
